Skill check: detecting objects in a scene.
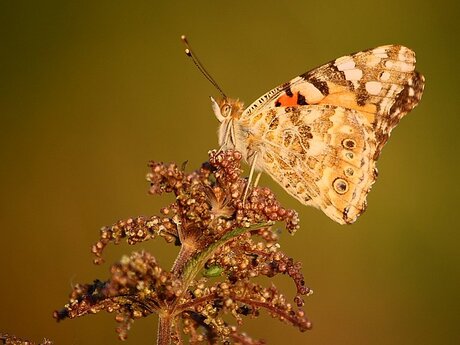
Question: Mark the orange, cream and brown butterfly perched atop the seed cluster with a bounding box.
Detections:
[211,45,425,224]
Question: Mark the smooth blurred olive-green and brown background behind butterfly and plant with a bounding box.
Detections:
[0,0,460,345]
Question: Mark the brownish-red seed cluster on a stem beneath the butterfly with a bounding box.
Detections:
[54,150,311,344]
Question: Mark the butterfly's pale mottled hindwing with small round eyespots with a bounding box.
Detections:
[255,105,376,224]
